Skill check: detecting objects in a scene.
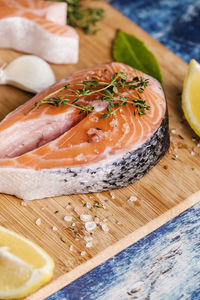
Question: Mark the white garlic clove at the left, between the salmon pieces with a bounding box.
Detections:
[0,55,56,93]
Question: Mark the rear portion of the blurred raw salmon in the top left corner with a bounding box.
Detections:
[0,0,67,25]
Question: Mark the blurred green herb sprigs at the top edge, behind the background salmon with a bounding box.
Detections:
[49,0,105,34]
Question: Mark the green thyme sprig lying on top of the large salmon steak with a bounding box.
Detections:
[26,72,150,119]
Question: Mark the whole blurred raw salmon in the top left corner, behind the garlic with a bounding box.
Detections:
[0,0,79,64]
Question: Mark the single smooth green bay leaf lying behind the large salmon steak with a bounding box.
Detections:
[112,30,162,82]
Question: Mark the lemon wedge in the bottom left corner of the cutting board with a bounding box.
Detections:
[0,226,54,299]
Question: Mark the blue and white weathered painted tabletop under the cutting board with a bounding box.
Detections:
[48,0,200,300]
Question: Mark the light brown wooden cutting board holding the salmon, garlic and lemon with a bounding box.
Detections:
[0,2,200,300]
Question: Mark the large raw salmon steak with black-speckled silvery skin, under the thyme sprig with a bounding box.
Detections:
[0,62,169,200]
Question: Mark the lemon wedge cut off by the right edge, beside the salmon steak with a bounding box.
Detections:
[182,59,200,136]
